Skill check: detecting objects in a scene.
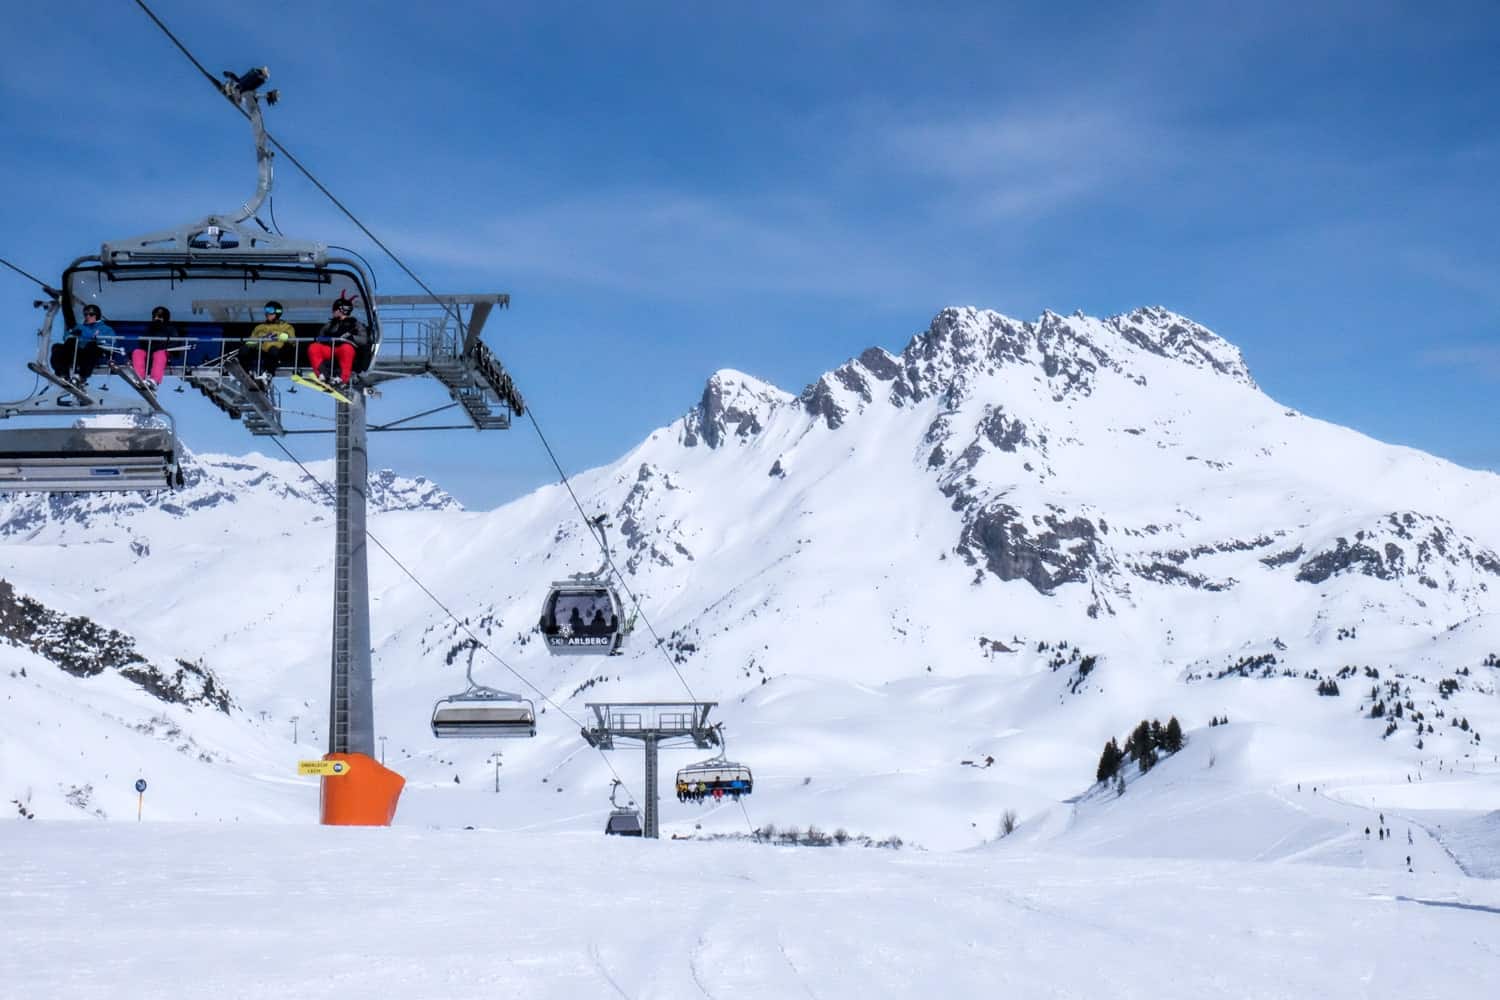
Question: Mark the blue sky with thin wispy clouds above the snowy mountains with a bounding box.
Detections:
[0,0,1500,507]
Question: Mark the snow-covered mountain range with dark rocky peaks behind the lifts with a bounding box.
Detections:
[0,309,1500,863]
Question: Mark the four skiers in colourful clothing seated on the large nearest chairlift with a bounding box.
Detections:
[50,295,371,390]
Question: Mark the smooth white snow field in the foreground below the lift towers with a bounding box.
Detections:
[0,822,1500,1000]
